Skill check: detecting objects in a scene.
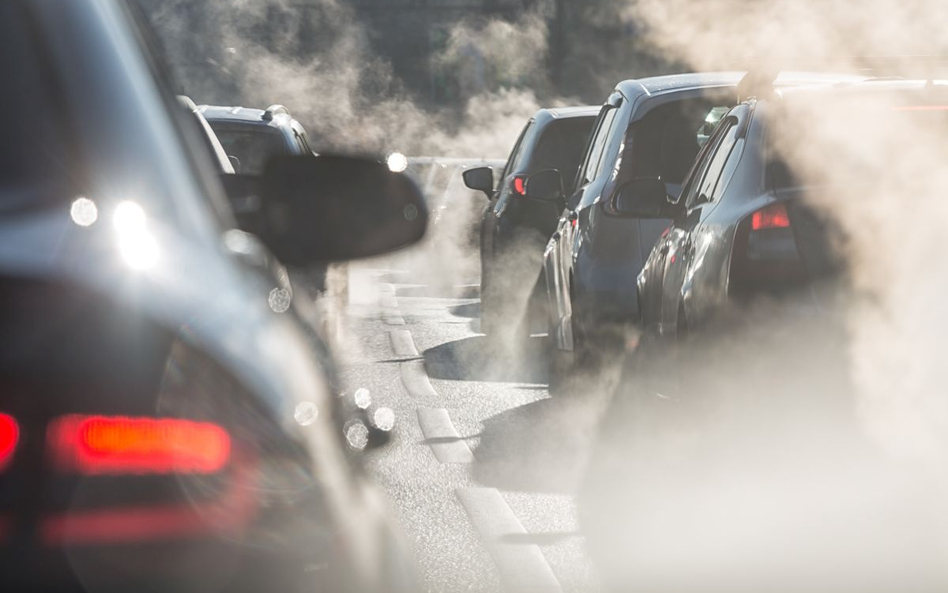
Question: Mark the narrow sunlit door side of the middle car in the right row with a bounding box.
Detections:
[546,93,622,350]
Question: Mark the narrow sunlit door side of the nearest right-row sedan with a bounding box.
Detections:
[657,106,744,339]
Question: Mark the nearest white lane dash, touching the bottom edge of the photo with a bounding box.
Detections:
[456,488,562,593]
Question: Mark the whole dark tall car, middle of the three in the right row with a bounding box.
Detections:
[527,72,859,388]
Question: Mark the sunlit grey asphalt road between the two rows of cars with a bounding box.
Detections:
[340,261,601,592]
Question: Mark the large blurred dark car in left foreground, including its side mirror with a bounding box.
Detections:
[0,0,426,591]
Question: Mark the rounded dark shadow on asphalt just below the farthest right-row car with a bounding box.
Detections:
[425,336,549,383]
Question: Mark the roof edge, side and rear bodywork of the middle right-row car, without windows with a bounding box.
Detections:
[544,73,740,350]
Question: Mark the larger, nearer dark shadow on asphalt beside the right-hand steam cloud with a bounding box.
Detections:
[472,393,603,494]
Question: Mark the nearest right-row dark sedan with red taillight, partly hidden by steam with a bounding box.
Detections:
[618,80,945,345]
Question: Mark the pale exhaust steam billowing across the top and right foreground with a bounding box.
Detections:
[143,0,948,593]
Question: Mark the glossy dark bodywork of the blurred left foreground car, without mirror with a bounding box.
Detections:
[0,0,414,590]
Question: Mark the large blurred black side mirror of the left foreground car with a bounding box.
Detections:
[222,155,428,265]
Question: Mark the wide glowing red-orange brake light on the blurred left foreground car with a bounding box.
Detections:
[47,415,231,474]
